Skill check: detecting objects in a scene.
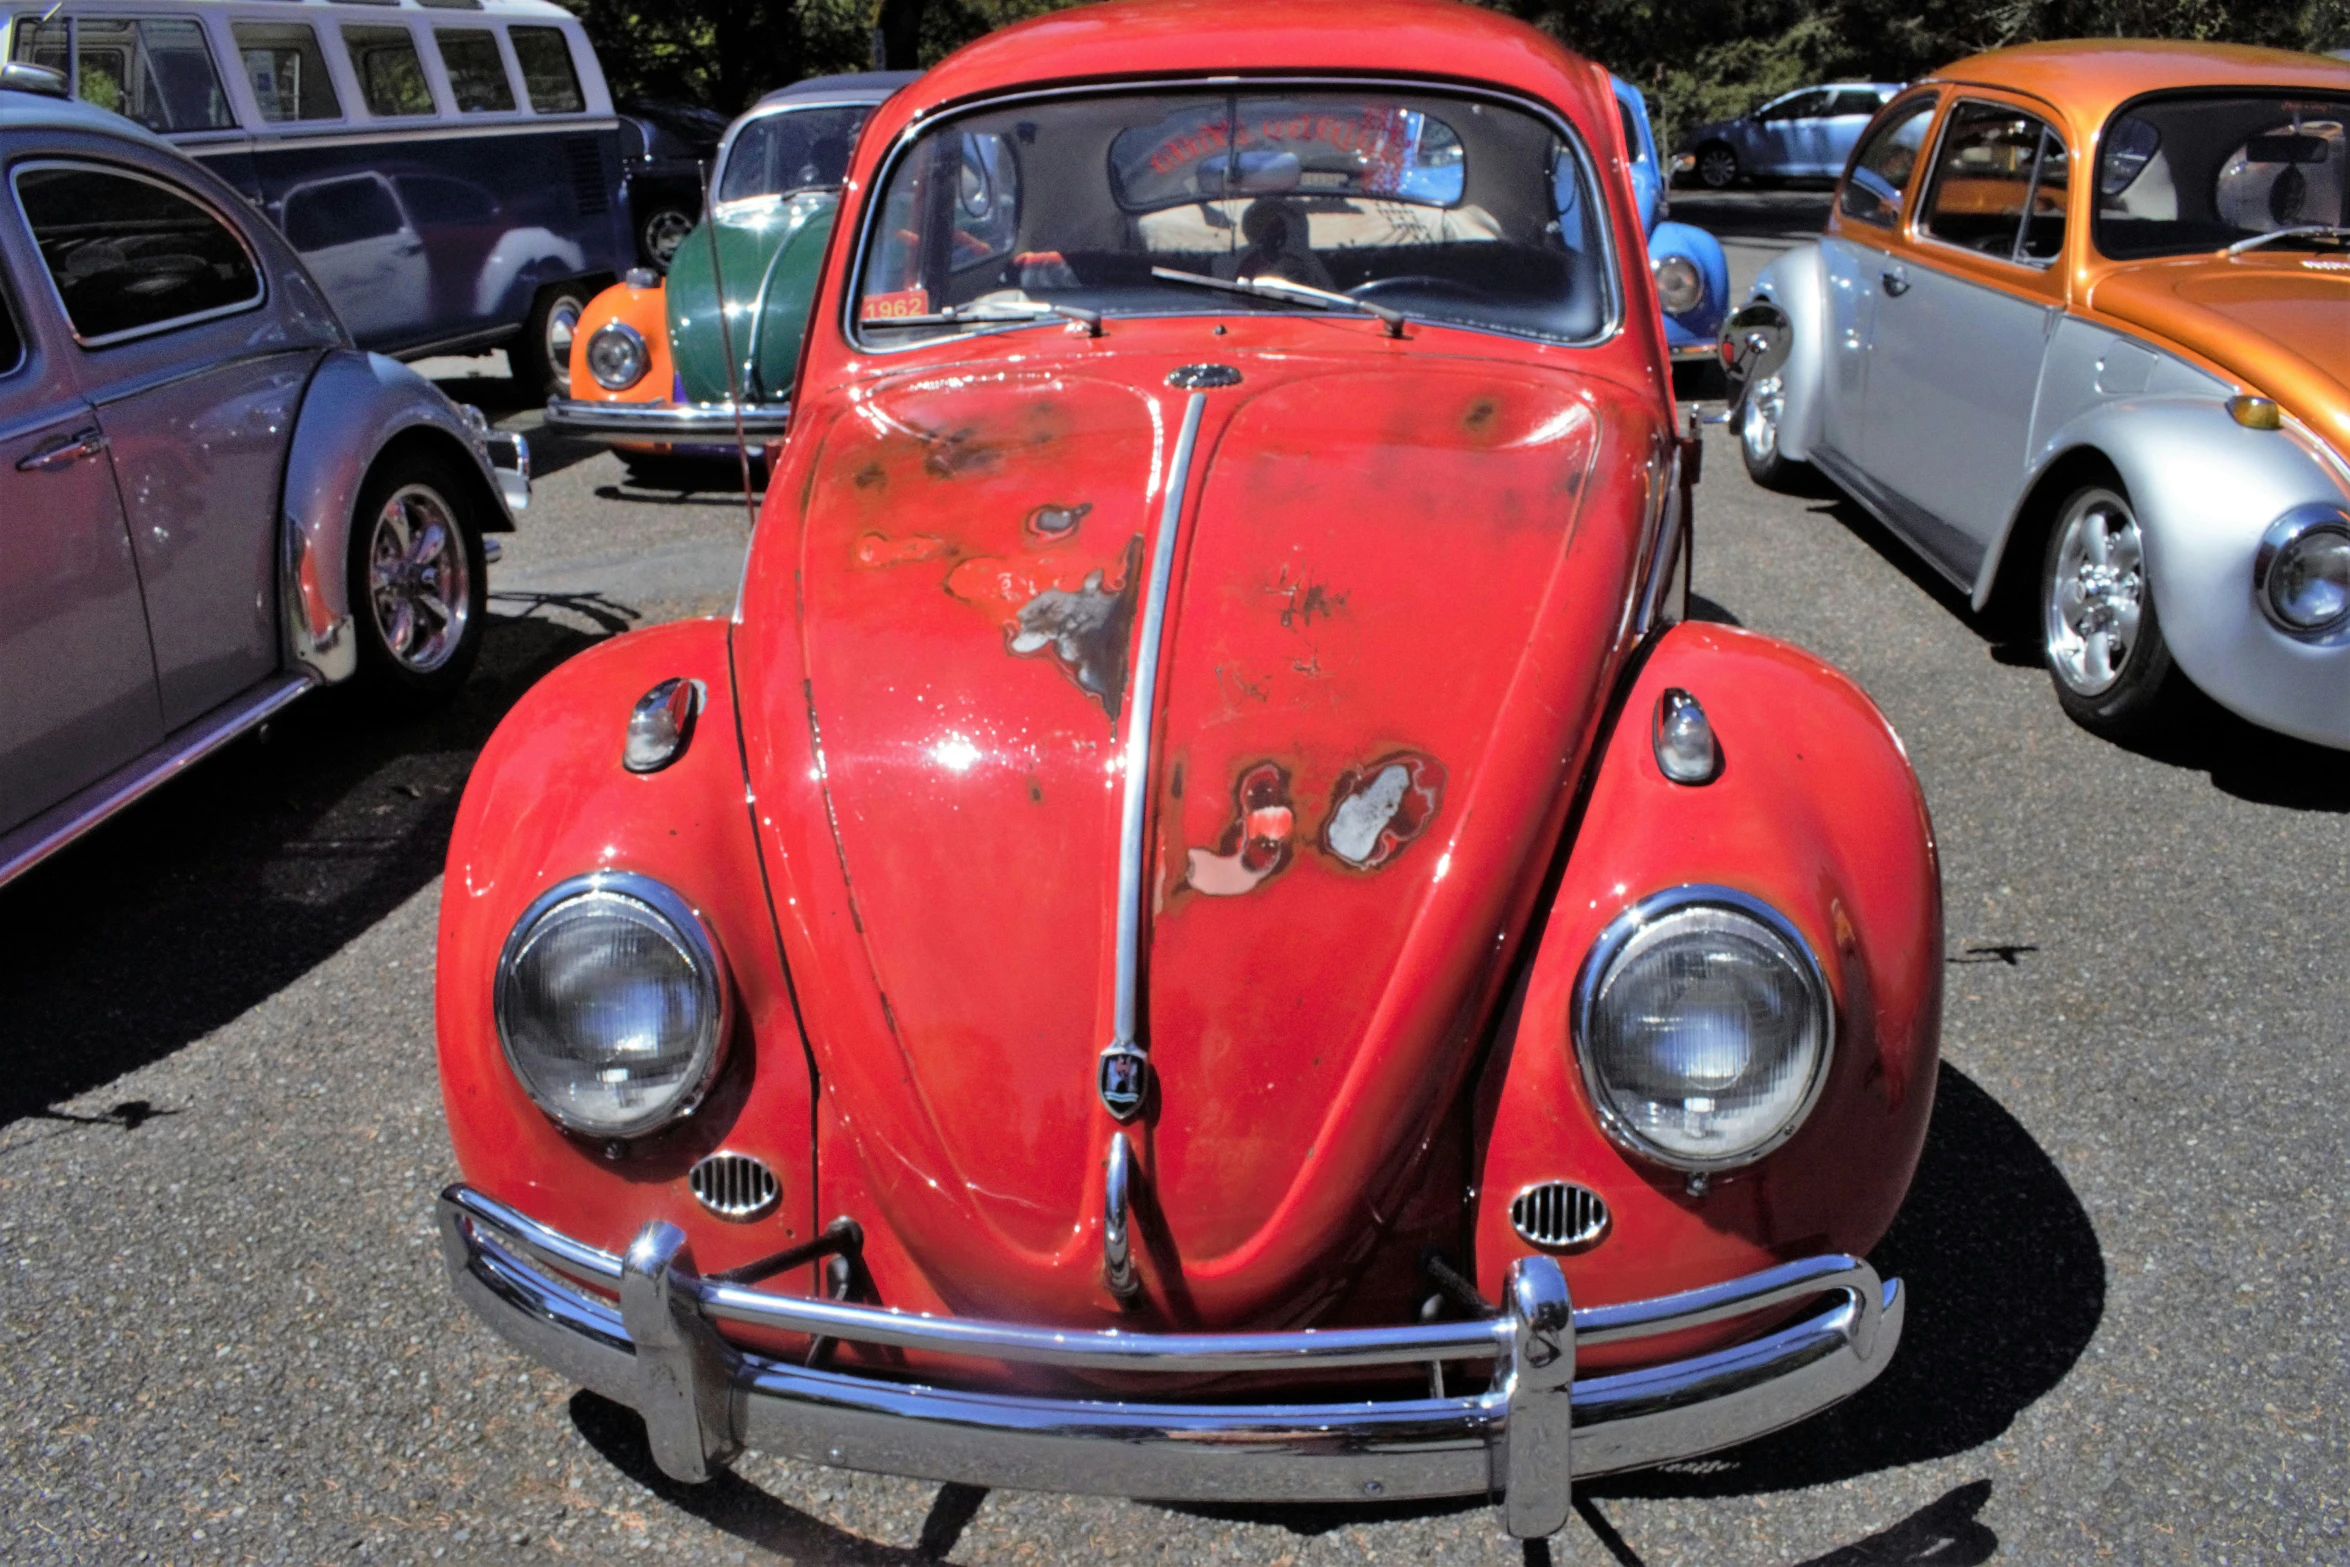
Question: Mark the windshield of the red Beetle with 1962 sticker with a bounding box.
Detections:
[858,92,1610,348]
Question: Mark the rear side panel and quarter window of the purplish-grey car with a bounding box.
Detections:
[14,160,317,728]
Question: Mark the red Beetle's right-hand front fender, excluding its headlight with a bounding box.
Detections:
[1473,625,1943,1365]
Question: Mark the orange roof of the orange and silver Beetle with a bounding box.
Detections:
[1929,38,2350,129]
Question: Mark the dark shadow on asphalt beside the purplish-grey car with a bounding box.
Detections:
[0,601,635,1128]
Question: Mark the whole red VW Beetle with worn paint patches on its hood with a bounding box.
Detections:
[439,0,1941,1536]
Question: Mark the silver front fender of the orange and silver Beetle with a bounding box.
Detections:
[2002,395,2350,745]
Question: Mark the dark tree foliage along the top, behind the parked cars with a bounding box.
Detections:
[569,0,2350,139]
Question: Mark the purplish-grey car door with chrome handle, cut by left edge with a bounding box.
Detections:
[0,246,162,832]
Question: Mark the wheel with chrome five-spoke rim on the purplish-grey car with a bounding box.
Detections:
[345,446,489,709]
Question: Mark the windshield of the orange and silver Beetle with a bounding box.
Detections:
[2096,94,2350,261]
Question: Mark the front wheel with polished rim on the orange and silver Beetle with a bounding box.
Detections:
[2037,479,2188,740]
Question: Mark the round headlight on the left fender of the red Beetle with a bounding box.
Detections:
[494,874,726,1137]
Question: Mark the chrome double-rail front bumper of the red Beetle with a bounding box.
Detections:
[439,1186,1904,1539]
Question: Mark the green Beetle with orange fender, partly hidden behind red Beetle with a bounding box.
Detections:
[548,70,914,463]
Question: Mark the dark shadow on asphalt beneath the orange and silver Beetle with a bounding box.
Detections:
[1814,495,2350,815]
